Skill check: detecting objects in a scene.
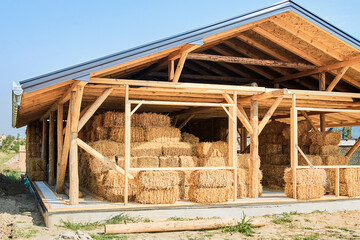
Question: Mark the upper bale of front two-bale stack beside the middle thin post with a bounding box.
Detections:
[191,170,233,188]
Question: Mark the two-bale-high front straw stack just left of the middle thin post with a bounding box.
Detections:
[188,170,233,204]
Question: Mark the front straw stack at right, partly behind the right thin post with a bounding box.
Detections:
[284,168,326,200]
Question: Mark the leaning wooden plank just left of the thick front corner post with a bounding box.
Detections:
[56,94,75,193]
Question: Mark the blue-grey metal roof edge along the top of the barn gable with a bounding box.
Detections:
[20,0,360,92]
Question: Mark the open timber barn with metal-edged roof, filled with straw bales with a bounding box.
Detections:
[12,1,360,225]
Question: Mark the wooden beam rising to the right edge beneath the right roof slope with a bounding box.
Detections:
[273,57,360,83]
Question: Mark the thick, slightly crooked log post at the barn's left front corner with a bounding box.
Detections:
[69,86,84,205]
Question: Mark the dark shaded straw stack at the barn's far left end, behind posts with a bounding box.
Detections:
[26,121,47,181]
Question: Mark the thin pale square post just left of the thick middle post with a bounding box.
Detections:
[228,91,237,201]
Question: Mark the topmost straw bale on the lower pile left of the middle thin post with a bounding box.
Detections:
[195,141,229,158]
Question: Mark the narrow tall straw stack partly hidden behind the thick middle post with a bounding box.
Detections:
[237,154,263,198]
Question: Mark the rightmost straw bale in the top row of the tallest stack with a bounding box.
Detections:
[136,113,170,128]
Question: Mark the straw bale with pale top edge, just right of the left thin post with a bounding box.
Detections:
[130,142,162,157]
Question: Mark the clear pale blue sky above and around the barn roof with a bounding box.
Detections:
[0,0,360,136]
